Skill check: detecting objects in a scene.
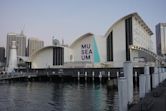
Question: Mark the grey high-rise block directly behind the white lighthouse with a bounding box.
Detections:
[6,31,26,66]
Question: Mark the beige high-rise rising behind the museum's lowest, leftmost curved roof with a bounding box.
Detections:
[27,38,44,56]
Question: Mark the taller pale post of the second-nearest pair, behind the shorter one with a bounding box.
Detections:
[144,64,151,93]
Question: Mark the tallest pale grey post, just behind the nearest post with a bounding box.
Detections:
[123,61,133,104]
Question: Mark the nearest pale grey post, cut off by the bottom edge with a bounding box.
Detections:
[118,77,128,111]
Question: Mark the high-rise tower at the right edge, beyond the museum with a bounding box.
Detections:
[156,23,166,55]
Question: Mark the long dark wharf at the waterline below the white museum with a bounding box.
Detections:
[0,68,123,80]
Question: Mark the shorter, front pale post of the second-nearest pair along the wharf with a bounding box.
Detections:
[139,74,146,98]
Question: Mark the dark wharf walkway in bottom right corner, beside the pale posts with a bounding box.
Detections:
[129,80,166,111]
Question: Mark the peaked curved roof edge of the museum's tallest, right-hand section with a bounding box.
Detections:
[105,12,153,37]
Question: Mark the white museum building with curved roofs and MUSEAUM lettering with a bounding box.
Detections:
[29,13,160,68]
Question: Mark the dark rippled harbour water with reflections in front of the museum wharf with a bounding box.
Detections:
[0,82,118,111]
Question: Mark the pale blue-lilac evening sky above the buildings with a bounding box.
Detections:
[0,0,166,47]
